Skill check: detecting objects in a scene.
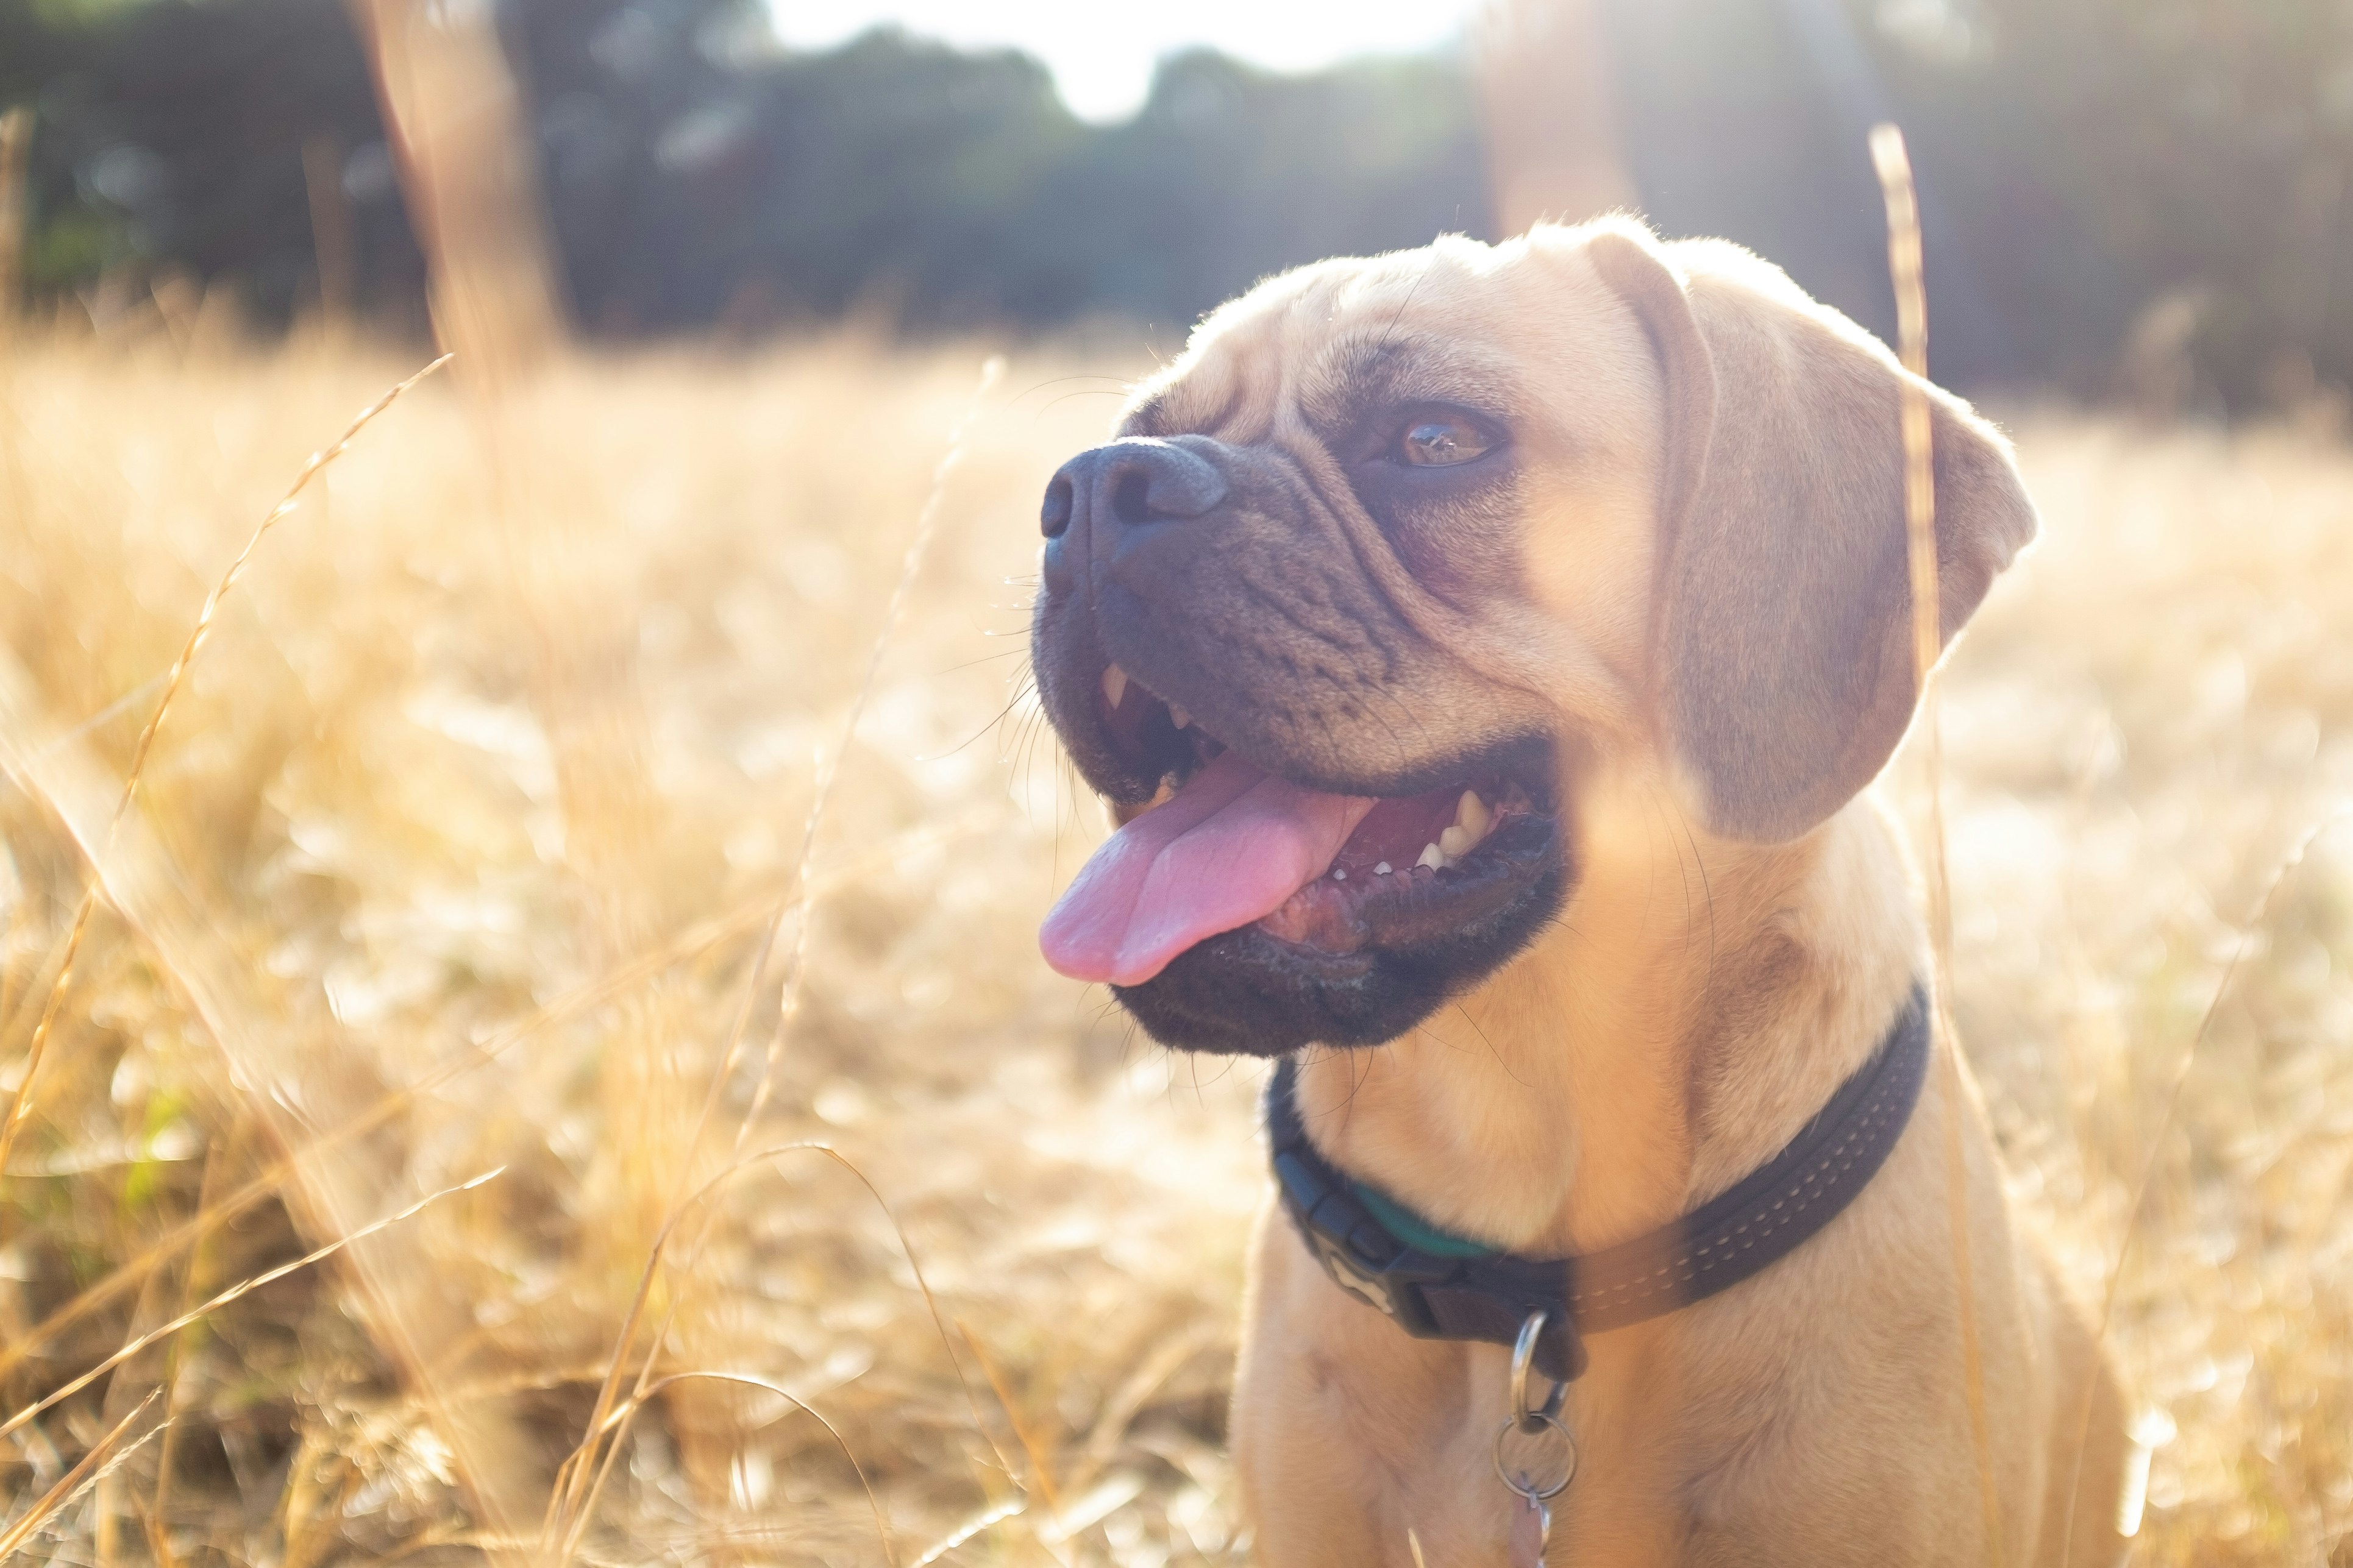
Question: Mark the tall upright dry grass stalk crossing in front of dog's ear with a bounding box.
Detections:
[1871,124,2002,1563]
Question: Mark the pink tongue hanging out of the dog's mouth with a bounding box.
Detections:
[1038,752,1372,985]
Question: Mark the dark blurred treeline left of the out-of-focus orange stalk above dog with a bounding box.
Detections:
[0,0,1485,334]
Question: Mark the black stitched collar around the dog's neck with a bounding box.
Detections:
[1266,985,1929,1382]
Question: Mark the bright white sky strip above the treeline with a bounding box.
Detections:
[769,0,1480,120]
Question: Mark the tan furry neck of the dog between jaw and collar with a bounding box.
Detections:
[1299,776,1920,1255]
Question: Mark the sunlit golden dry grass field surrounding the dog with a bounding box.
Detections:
[0,322,2353,1568]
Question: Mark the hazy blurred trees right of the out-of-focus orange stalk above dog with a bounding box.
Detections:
[1607,0,2353,406]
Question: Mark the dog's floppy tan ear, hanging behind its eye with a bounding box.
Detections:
[1589,225,2035,842]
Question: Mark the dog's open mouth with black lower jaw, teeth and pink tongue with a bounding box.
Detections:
[1040,665,1565,1051]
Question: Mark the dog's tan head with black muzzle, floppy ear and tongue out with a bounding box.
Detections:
[1033,221,2035,1053]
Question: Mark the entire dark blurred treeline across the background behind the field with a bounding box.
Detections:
[0,0,2353,405]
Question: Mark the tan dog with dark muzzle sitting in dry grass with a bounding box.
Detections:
[1035,221,2125,1568]
